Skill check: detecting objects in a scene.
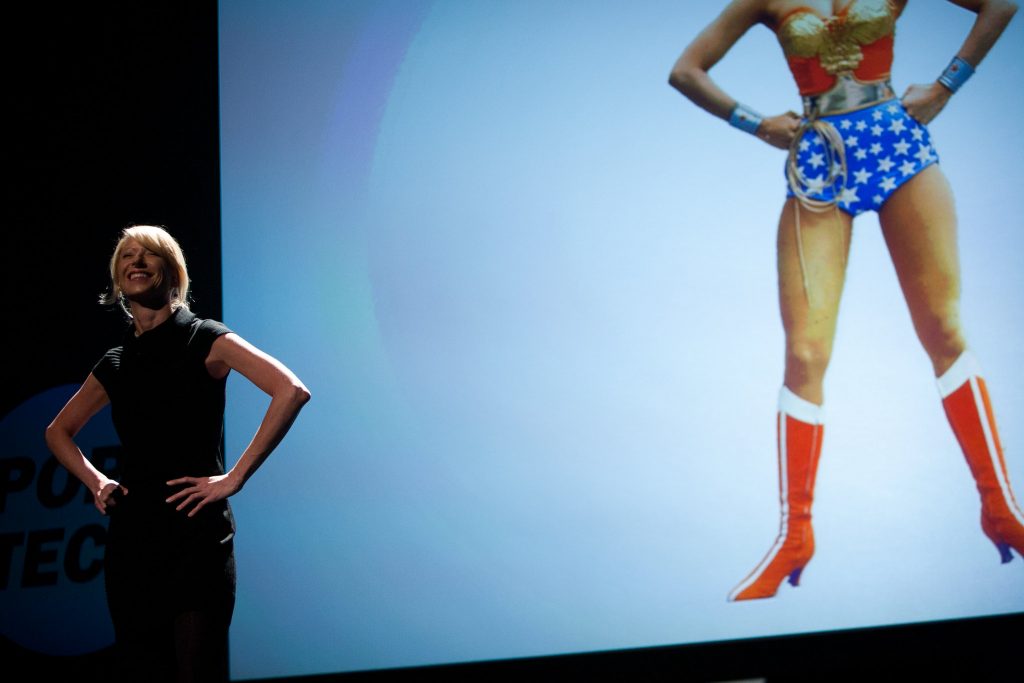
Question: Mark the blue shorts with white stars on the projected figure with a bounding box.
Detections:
[786,98,939,216]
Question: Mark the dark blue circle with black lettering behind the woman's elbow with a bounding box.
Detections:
[0,385,121,655]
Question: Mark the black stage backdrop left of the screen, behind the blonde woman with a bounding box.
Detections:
[0,0,221,681]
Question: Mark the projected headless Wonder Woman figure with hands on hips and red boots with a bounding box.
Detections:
[670,0,1024,600]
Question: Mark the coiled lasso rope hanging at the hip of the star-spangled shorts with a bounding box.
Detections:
[785,113,847,305]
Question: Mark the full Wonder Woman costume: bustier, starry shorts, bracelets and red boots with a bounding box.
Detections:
[729,0,1024,600]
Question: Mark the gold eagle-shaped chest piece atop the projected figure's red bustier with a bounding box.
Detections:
[778,0,896,76]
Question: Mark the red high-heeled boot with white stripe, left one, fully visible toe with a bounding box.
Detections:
[729,386,824,600]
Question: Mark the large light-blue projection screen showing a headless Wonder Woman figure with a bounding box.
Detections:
[220,0,1024,679]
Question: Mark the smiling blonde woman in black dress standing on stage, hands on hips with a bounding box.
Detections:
[46,225,309,681]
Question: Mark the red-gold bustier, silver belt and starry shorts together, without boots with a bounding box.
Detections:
[778,0,938,216]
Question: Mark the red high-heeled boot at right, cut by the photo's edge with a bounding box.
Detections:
[938,351,1024,562]
